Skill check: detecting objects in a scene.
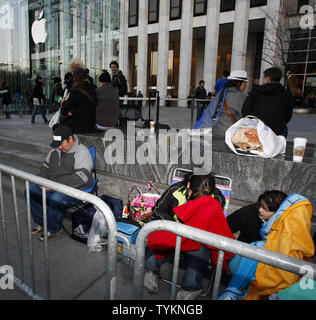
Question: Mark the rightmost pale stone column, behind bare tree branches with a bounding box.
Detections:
[260,0,285,83]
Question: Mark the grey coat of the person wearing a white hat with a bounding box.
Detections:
[212,87,246,138]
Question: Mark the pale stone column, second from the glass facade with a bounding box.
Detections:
[137,0,148,97]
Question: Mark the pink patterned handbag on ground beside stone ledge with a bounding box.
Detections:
[127,181,161,221]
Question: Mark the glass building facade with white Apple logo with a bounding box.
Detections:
[0,0,120,112]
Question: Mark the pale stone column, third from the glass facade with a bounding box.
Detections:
[157,1,169,106]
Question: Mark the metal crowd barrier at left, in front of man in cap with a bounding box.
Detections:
[0,164,118,300]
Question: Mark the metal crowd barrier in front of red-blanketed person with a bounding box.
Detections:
[133,221,316,300]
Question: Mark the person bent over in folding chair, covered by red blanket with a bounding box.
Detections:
[145,174,235,300]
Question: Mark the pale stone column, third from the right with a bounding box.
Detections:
[203,0,221,92]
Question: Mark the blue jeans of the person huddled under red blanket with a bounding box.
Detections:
[145,245,211,291]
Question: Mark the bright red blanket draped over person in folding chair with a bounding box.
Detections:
[147,196,234,269]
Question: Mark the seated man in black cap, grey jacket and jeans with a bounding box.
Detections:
[30,125,93,241]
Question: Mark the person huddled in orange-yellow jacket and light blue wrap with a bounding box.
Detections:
[219,194,315,300]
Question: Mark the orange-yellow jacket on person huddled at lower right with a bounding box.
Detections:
[245,200,315,300]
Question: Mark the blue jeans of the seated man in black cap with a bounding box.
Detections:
[30,184,73,233]
